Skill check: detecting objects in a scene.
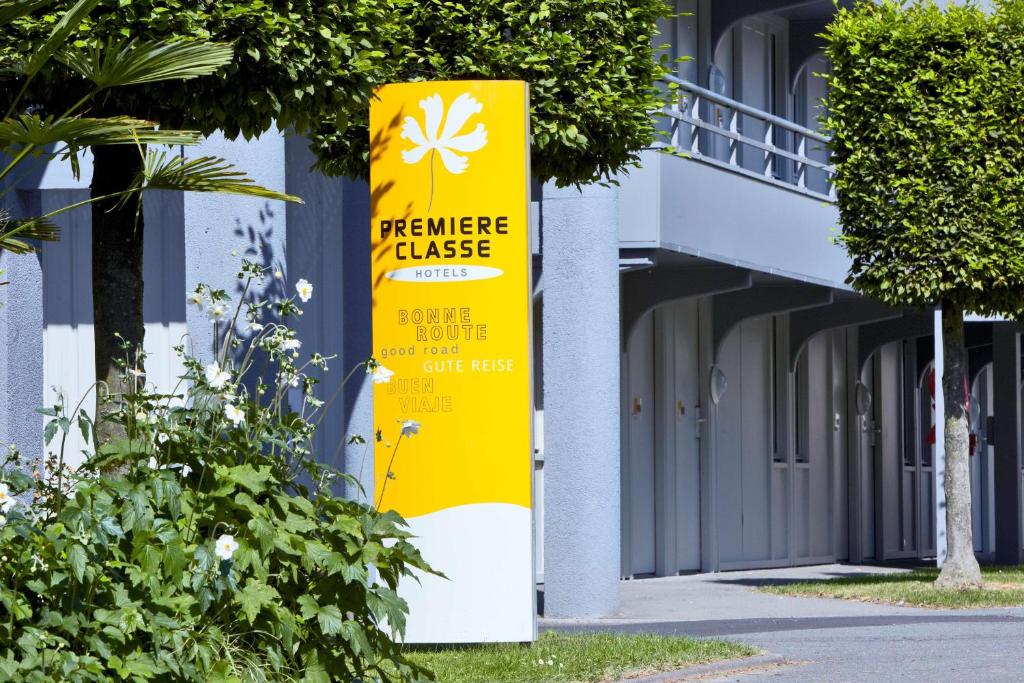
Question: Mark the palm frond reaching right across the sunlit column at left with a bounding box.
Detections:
[133,151,302,204]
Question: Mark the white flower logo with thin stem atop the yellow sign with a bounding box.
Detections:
[401,92,487,211]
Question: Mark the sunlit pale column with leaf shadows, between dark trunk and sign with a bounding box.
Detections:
[181,130,286,366]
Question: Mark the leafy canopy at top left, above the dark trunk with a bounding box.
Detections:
[0,0,397,137]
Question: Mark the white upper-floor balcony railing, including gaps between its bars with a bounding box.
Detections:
[665,76,836,201]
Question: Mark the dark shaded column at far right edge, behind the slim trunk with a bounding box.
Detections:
[992,323,1024,564]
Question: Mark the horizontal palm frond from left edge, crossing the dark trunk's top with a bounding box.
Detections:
[0,114,200,150]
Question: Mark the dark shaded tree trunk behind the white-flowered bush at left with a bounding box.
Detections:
[91,144,145,443]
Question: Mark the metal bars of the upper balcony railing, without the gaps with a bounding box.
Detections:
[664,76,836,200]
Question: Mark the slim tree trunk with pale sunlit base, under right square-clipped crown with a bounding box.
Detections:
[935,302,981,589]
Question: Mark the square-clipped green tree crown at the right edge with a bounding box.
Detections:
[823,0,1024,315]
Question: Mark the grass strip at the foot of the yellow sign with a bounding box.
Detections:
[411,632,760,683]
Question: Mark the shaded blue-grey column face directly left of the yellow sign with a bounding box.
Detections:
[286,136,374,498]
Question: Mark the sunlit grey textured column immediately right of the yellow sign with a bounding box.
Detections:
[543,186,621,617]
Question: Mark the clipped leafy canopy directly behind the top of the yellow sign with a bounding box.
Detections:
[312,0,669,185]
